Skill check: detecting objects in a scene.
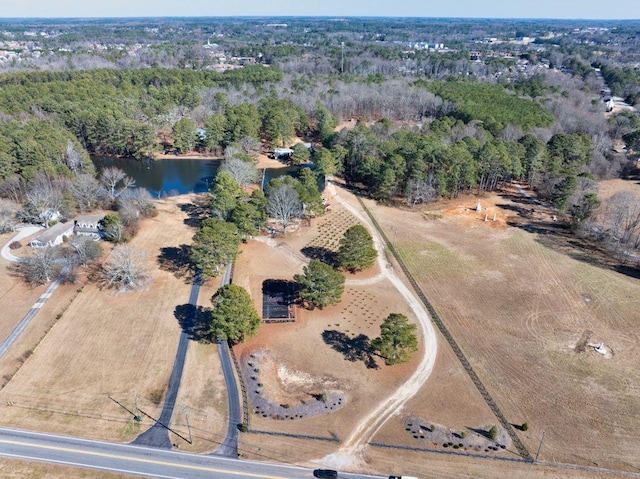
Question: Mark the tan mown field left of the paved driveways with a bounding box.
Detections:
[0,197,223,447]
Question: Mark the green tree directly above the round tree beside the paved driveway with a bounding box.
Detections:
[191,218,240,277]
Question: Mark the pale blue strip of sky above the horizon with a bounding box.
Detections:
[0,0,640,20]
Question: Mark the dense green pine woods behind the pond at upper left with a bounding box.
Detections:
[0,66,282,161]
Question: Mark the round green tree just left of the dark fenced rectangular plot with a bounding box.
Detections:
[211,284,261,343]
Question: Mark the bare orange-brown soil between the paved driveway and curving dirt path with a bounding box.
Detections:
[234,191,420,450]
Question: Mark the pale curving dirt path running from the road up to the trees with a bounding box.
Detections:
[318,182,438,469]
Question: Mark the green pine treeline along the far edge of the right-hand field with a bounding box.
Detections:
[324,117,598,231]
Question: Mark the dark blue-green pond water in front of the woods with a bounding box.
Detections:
[91,156,308,197]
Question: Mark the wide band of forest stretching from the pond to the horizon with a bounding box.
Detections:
[0,19,640,258]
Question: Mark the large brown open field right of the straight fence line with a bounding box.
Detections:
[368,186,640,472]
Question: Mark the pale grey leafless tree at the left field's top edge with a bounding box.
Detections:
[100,245,150,291]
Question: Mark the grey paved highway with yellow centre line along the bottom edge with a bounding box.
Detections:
[0,428,374,479]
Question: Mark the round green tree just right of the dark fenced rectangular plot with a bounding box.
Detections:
[293,259,345,308]
